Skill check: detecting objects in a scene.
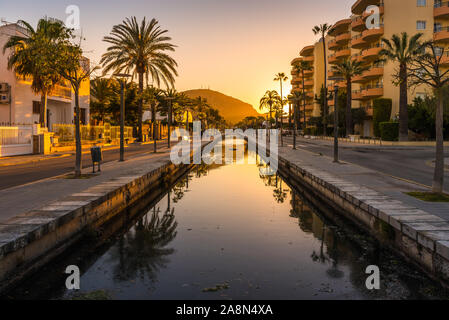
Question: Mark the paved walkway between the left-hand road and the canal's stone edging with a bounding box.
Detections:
[0,147,170,224]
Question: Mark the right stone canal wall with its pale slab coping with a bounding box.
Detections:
[279,148,449,287]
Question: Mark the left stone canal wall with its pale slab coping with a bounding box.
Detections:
[0,145,204,292]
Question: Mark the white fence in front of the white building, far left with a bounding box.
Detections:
[0,125,33,157]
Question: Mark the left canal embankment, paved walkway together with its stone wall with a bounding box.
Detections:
[0,144,204,291]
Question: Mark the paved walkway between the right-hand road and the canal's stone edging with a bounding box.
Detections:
[279,146,449,221]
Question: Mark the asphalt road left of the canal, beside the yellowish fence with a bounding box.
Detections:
[0,141,167,190]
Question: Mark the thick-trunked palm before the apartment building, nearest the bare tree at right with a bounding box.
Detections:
[379,32,423,141]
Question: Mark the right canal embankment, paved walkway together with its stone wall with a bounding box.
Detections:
[272,146,449,286]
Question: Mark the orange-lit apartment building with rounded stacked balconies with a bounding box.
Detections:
[292,0,449,136]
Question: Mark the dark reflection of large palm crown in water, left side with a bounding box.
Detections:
[111,207,178,282]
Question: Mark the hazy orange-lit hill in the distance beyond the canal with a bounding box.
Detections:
[184,89,260,124]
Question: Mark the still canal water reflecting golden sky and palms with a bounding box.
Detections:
[7,144,447,299]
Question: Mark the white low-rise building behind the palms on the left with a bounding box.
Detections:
[0,24,90,130]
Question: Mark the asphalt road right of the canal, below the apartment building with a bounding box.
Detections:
[287,139,449,191]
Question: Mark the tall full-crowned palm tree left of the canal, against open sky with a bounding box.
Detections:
[100,17,178,141]
